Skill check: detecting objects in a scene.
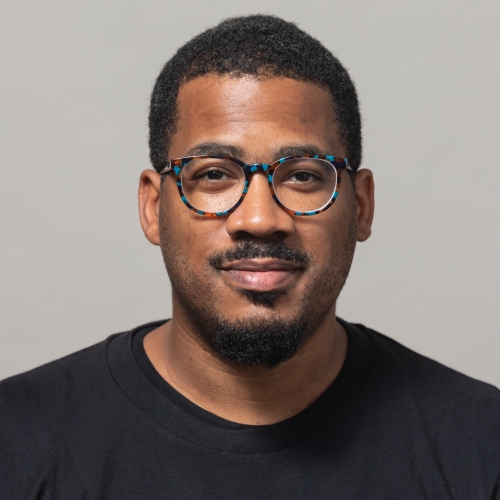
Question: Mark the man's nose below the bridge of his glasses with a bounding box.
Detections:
[226,172,295,238]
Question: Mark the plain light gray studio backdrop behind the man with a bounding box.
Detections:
[0,0,500,385]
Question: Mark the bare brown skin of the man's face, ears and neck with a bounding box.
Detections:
[139,76,374,425]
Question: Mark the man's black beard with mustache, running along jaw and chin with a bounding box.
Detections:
[160,212,356,369]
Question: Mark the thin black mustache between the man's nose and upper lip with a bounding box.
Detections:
[208,240,310,269]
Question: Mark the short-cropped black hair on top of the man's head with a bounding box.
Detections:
[149,15,362,171]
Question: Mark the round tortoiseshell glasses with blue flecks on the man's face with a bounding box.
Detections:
[160,155,352,217]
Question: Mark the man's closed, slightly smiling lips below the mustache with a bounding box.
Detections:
[220,259,304,292]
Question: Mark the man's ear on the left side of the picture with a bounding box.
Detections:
[139,170,161,245]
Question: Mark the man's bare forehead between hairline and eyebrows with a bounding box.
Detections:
[169,75,344,161]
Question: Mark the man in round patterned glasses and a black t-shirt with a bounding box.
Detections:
[0,16,500,500]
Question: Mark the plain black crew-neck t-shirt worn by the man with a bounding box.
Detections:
[0,322,500,500]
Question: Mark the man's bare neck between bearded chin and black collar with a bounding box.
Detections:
[144,306,347,425]
